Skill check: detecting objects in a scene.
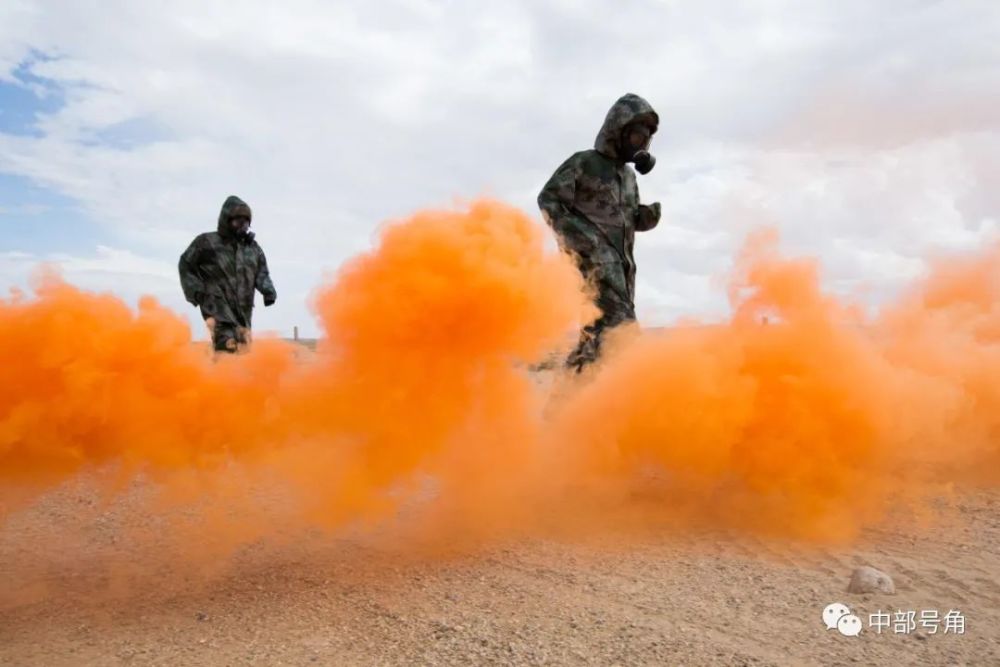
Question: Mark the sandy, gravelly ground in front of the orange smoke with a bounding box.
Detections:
[0,486,1000,666]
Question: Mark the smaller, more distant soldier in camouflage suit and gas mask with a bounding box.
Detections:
[178,196,277,352]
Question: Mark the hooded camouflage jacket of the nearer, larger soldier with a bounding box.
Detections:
[538,93,660,302]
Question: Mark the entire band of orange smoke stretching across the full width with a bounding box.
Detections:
[0,202,1000,560]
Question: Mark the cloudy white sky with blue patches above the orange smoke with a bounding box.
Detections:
[0,0,1000,335]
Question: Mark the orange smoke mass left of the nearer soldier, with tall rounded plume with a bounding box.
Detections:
[0,198,592,525]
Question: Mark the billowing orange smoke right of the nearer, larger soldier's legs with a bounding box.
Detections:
[558,234,1000,538]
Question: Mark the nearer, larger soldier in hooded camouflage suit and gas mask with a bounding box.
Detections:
[538,93,660,371]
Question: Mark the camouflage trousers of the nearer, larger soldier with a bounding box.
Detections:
[566,262,635,373]
